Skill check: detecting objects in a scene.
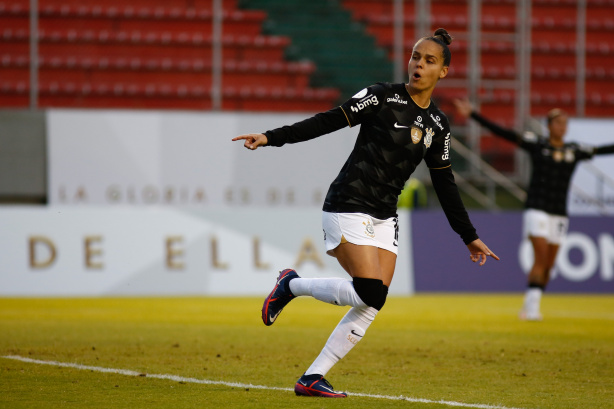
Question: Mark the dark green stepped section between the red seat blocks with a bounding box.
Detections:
[239,0,393,102]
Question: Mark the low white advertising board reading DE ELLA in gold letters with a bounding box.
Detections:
[0,206,413,296]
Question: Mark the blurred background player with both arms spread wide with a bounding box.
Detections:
[454,99,614,321]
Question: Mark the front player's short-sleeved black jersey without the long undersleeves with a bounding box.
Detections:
[324,83,450,219]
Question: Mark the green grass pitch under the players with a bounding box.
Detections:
[0,294,614,409]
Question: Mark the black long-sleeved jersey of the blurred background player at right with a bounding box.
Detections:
[471,112,607,216]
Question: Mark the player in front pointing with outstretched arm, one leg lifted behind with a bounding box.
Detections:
[233,29,499,398]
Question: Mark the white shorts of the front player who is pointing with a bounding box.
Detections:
[322,212,399,257]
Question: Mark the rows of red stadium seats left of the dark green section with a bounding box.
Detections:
[0,0,339,111]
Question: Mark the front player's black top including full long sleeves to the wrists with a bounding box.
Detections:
[265,83,478,244]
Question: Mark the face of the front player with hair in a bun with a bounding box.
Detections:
[407,40,448,91]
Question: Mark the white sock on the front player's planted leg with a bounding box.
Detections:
[304,306,378,376]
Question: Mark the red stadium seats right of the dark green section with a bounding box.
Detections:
[342,0,614,122]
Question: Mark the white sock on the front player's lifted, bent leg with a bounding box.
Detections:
[290,278,367,308]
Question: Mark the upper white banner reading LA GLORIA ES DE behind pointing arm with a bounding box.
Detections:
[47,110,358,208]
